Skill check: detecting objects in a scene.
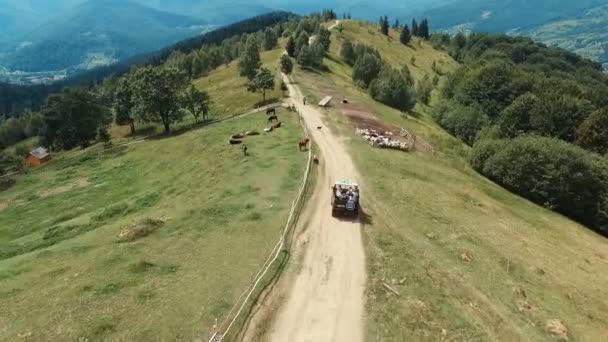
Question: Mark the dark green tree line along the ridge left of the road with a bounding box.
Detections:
[0,14,304,172]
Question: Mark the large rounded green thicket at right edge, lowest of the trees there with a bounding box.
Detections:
[470,136,608,234]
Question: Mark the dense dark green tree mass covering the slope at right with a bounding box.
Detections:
[434,34,608,234]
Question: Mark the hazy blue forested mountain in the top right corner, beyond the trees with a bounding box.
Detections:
[422,0,608,63]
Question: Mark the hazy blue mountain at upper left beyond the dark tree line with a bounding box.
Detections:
[3,0,208,71]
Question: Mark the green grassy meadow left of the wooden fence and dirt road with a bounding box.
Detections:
[0,106,306,341]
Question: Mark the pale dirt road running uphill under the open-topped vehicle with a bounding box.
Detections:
[262,73,366,342]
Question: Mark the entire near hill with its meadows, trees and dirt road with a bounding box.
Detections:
[0,7,608,342]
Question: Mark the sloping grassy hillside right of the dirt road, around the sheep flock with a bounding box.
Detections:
[296,22,608,341]
